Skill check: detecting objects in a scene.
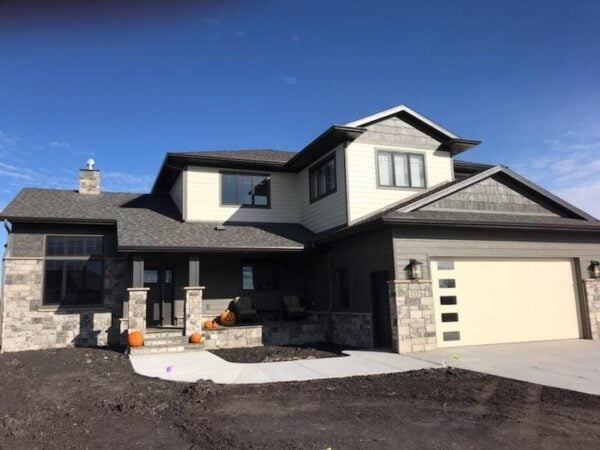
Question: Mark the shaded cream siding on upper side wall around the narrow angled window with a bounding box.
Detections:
[298,145,346,233]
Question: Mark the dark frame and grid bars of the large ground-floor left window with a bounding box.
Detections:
[40,233,106,308]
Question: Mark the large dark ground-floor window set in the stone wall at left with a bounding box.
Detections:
[43,236,103,306]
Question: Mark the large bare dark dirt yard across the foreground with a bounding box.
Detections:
[0,349,600,449]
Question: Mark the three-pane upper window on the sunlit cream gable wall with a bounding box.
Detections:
[377,151,425,188]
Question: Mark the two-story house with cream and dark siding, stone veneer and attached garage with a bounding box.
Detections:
[0,105,600,352]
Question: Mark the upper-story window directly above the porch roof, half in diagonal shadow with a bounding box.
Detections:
[221,172,271,208]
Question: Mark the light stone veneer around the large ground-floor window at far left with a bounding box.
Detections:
[1,257,123,352]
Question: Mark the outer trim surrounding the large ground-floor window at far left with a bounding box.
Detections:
[38,233,106,311]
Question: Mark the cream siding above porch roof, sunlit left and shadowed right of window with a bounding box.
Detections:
[185,166,300,223]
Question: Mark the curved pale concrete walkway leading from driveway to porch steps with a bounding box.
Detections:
[130,350,439,384]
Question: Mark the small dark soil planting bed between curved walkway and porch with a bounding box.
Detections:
[210,343,346,363]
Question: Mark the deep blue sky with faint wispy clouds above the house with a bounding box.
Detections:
[0,0,600,256]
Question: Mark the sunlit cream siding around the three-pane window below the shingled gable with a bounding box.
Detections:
[346,142,453,223]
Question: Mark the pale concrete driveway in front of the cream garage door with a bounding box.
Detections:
[410,339,600,395]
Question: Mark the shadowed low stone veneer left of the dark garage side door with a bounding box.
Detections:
[309,311,373,348]
